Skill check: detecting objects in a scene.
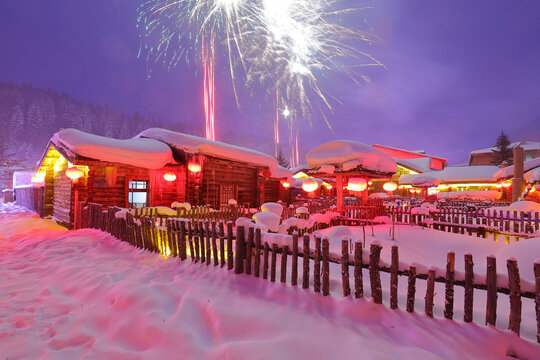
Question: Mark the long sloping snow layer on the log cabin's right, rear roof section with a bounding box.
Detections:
[136,128,278,171]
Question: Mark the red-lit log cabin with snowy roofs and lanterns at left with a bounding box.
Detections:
[33,129,277,227]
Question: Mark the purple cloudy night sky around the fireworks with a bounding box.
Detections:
[0,0,540,164]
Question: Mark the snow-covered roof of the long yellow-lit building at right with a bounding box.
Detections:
[399,166,499,185]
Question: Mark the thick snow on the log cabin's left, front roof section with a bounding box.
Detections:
[51,129,175,169]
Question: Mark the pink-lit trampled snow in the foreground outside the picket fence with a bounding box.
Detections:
[0,205,540,359]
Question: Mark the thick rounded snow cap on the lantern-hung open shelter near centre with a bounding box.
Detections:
[306,140,397,173]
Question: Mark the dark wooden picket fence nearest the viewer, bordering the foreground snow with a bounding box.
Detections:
[78,204,540,343]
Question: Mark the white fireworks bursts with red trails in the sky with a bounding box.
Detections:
[138,0,381,147]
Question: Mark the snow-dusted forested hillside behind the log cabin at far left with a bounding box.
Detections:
[0,82,193,166]
